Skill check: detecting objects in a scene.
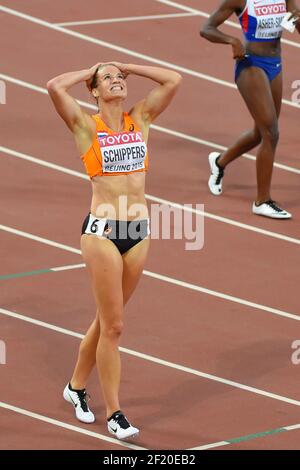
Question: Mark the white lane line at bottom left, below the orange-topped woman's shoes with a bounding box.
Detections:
[0,401,147,450]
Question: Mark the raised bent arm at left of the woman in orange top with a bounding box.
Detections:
[47,64,100,133]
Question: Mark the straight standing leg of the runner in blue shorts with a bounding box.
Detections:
[237,67,281,204]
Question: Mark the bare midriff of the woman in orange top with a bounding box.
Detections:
[91,172,149,220]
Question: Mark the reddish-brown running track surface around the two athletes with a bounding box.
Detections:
[0,0,300,449]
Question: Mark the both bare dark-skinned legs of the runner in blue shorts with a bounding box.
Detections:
[218,67,282,204]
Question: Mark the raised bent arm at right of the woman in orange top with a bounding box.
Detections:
[109,62,182,125]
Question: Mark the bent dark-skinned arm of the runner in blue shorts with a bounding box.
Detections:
[200,0,245,59]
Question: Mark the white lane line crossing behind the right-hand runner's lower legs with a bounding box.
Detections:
[0,73,300,175]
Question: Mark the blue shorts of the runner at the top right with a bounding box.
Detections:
[234,54,282,82]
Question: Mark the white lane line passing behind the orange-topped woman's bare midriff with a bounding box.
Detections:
[0,146,300,245]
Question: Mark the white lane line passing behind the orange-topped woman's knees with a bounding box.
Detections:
[0,308,300,406]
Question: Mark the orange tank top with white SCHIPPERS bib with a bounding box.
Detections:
[81,113,148,178]
